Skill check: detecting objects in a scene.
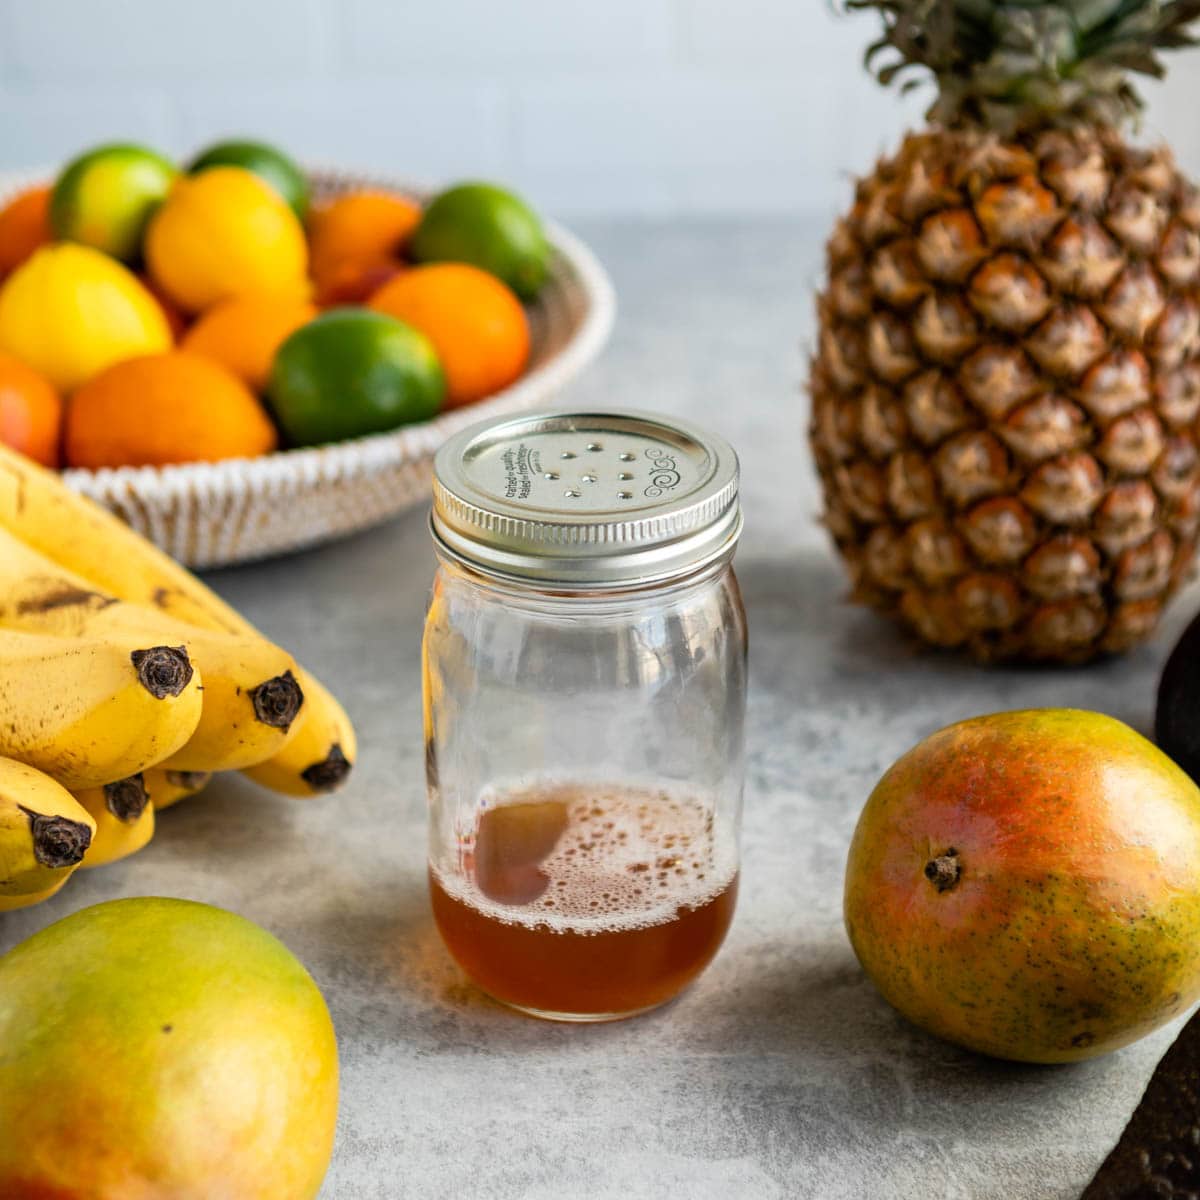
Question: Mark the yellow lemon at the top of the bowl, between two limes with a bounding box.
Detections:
[145,167,308,312]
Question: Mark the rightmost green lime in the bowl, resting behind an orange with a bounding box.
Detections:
[409,184,550,300]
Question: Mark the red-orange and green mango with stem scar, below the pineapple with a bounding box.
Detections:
[844,709,1200,1062]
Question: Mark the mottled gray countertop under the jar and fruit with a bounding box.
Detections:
[0,222,1200,1200]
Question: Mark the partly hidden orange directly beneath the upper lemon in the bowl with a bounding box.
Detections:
[180,292,317,391]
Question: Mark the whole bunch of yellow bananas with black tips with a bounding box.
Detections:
[0,445,358,912]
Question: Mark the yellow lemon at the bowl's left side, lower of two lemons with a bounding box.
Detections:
[0,242,172,391]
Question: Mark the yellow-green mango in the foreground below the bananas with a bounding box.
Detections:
[0,898,337,1200]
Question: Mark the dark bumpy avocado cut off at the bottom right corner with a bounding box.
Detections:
[1080,1014,1200,1200]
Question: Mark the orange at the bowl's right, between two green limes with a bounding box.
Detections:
[370,263,529,408]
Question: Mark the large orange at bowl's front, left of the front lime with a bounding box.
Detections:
[65,350,278,467]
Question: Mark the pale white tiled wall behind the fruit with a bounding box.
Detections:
[0,0,1200,223]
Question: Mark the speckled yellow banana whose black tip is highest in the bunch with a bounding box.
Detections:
[0,628,200,788]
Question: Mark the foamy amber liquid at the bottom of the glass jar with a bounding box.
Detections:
[430,785,738,1020]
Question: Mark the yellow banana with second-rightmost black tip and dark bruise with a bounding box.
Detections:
[0,528,304,770]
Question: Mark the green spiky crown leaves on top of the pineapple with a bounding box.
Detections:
[842,0,1200,137]
